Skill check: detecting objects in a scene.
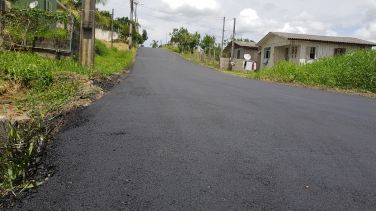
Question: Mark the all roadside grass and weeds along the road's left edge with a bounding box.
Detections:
[0,40,137,198]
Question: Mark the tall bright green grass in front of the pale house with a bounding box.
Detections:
[254,50,376,93]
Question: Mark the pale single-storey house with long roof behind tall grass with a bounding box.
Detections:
[257,32,376,69]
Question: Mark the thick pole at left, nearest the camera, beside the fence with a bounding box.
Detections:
[80,0,95,67]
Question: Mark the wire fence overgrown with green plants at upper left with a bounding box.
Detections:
[0,9,81,55]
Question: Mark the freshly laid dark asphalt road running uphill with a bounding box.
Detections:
[16,48,376,210]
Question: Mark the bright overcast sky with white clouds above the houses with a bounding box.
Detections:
[97,0,376,47]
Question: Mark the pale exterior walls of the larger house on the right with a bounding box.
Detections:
[259,36,371,69]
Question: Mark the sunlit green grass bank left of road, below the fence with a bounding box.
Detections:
[0,41,136,112]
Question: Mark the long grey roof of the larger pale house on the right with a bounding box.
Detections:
[258,32,376,46]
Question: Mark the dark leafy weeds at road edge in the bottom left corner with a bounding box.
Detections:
[0,113,50,191]
